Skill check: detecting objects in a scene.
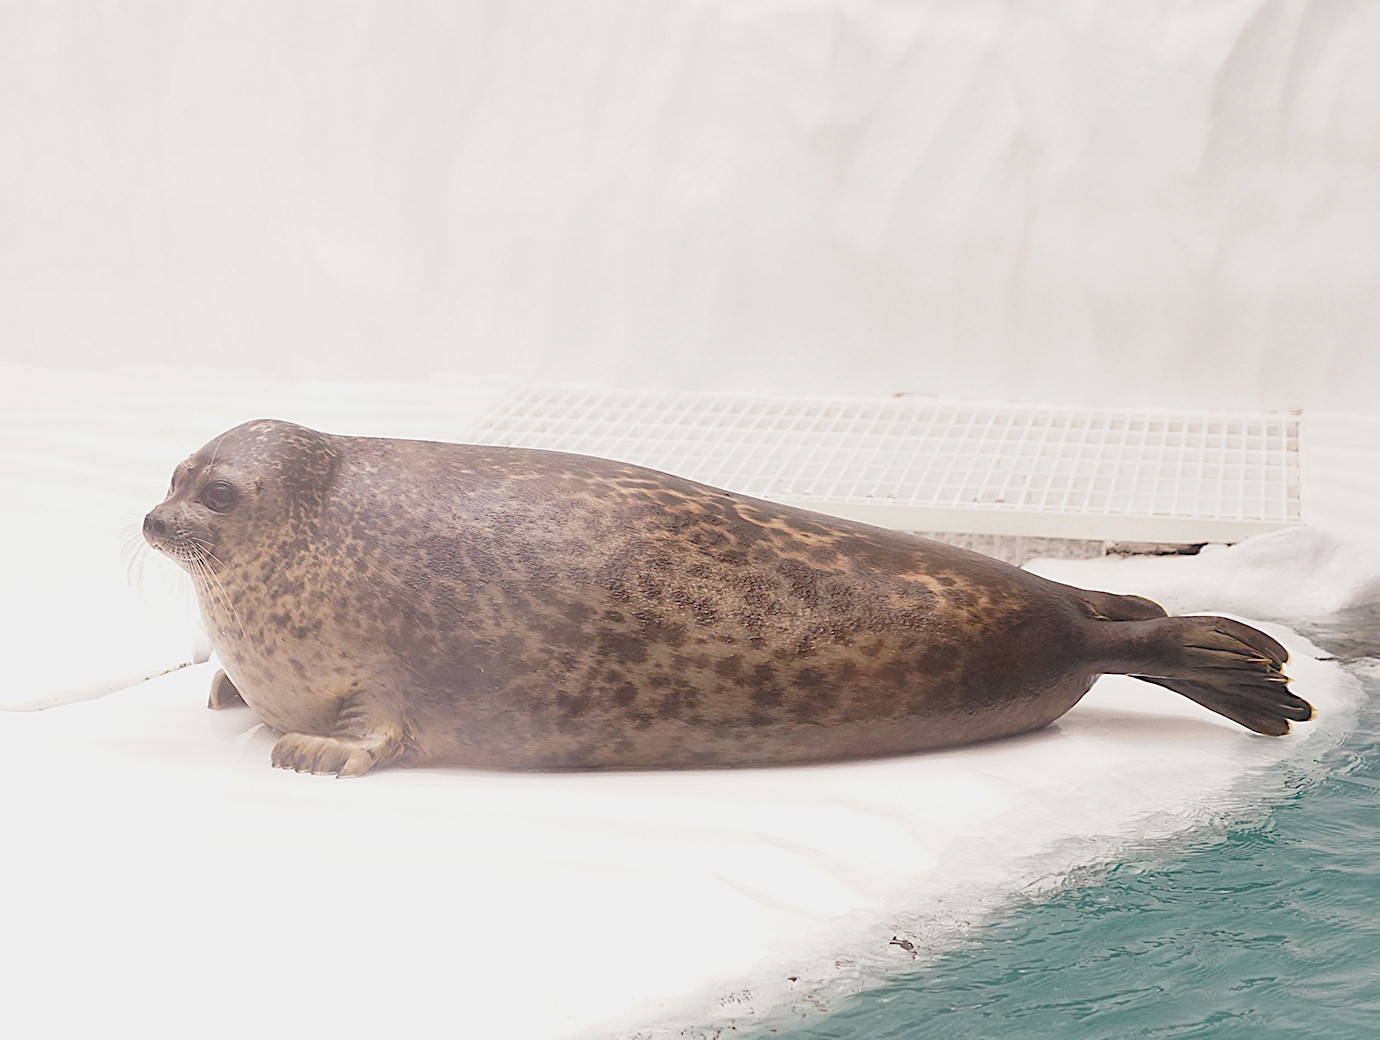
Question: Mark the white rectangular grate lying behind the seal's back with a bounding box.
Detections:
[476,388,1299,542]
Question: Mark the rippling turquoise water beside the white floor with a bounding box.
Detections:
[765,608,1380,1040]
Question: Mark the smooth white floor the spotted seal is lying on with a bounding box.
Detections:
[0,367,1380,1040]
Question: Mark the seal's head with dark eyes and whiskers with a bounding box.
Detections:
[144,419,337,574]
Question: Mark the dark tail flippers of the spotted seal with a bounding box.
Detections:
[1098,617,1312,737]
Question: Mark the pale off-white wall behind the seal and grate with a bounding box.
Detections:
[0,0,1380,412]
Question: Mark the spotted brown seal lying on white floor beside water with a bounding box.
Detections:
[144,419,1312,777]
